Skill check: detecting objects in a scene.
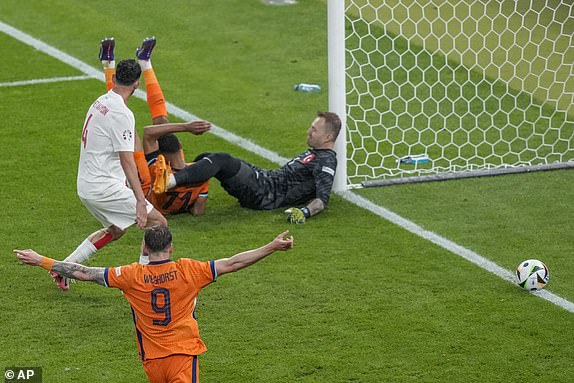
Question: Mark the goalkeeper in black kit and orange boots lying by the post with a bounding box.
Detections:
[153,112,341,223]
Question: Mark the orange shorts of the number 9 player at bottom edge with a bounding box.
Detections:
[143,354,199,383]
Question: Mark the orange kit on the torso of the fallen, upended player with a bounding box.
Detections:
[136,152,209,215]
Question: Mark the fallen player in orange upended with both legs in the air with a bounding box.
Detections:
[100,37,211,216]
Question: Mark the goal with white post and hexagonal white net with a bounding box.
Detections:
[328,0,574,190]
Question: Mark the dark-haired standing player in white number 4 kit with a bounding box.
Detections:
[52,59,167,290]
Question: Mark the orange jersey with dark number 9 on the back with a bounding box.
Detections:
[104,258,217,360]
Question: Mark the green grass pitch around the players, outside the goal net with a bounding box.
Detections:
[0,0,574,383]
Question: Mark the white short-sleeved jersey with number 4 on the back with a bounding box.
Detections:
[77,90,135,199]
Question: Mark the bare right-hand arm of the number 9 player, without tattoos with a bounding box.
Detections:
[215,230,293,276]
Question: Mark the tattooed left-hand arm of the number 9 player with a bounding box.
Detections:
[14,250,106,286]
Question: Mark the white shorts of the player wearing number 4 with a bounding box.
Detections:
[80,187,153,230]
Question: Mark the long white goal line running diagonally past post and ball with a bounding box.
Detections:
[0,21,574,313]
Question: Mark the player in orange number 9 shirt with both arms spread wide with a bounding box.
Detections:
[14,226,293,382]
